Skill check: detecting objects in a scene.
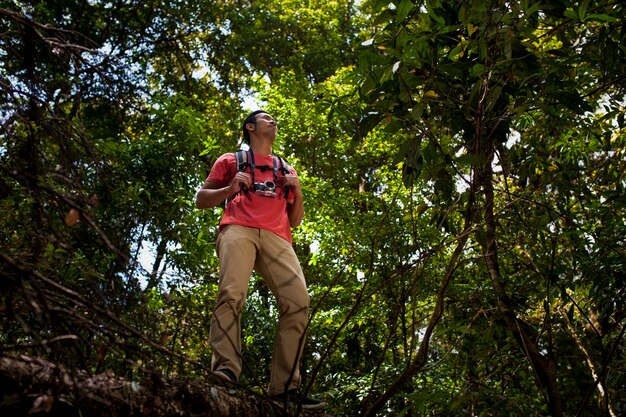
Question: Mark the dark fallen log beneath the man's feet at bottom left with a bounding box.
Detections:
[0,355,330,417]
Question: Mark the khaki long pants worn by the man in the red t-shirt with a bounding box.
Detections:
[210,225,309,395]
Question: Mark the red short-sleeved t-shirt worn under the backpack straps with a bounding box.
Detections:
[207,153,297,243]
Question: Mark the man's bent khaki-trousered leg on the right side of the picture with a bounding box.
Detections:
[255,230,309,396]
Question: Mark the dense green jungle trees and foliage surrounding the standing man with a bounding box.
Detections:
[0,0,626,416]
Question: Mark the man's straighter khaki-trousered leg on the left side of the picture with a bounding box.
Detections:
[210,225,259,379]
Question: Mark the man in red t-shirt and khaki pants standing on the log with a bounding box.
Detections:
[196,110,326,410]
